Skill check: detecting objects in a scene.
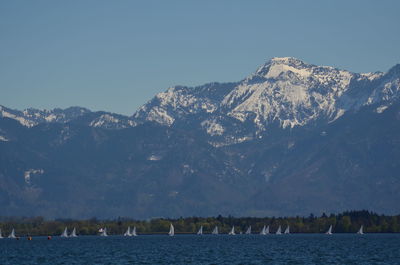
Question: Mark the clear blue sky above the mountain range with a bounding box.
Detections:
[0,0,400,115]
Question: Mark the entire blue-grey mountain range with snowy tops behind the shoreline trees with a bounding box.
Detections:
[0,58,400,218]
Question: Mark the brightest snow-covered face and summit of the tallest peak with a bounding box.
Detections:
[222,58,360,130]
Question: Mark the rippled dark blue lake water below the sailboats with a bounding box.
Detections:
[0,234,400,265]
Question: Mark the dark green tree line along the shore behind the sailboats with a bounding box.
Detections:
[0,210,400,236]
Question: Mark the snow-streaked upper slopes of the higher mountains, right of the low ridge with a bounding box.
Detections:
[133,57,400,142]
